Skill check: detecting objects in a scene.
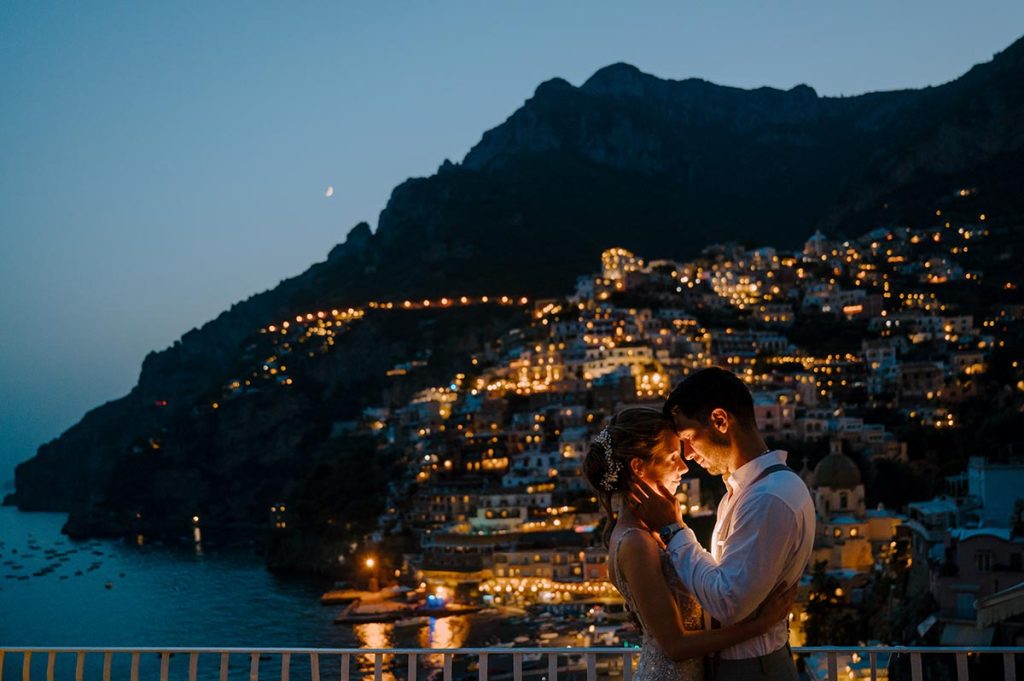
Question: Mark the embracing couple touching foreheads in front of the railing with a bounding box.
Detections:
[584,368,814,681]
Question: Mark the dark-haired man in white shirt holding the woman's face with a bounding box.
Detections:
[631,368,814,681]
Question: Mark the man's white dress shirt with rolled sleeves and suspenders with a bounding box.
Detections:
[668,450,814,659]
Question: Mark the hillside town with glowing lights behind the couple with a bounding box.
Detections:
[245,211,1024,645]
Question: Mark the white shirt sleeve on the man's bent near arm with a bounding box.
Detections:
[668,494,798,625]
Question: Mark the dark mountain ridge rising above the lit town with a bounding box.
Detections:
[10,40,1024,552]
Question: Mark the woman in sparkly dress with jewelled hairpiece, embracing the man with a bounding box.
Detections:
[583,407,797,681]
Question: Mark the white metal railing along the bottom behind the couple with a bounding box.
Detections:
[0,646,1024,681]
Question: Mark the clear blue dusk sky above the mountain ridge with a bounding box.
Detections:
[0,0,1024,481]
